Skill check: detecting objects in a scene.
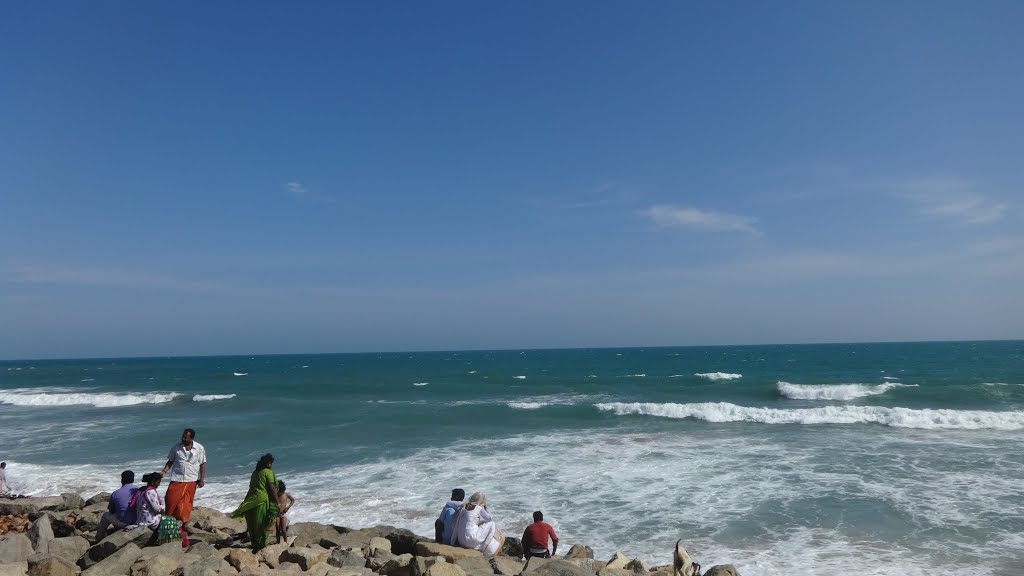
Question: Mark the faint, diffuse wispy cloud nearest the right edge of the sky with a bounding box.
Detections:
[896,178,1008,224]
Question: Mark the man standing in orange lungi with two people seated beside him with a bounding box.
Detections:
[96,428,206,547]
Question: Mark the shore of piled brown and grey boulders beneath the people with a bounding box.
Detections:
[0,493,738,576]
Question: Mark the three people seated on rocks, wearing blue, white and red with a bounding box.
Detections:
[434,488,558,559]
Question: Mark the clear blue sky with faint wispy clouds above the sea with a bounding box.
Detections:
[0,0,1024,360]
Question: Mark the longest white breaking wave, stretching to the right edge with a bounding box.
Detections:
[594,402,1024,430]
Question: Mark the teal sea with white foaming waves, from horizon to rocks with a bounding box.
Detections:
[0,341,1024,576]
